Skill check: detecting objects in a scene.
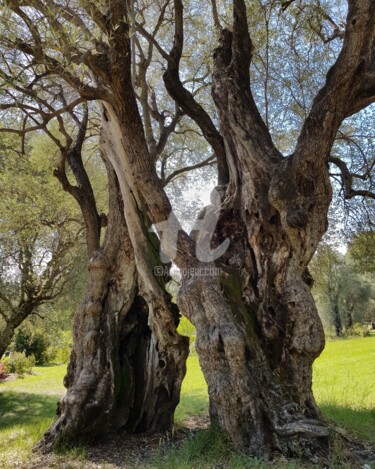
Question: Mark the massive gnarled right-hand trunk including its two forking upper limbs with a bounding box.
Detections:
[167,0,375,459]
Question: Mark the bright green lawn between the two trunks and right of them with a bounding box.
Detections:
[176,335,375,442]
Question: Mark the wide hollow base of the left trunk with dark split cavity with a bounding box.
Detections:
[35,164,188,452]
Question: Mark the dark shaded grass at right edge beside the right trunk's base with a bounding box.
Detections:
[319,404,375,443]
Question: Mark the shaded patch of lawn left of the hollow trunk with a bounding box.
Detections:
[0,391,60,430]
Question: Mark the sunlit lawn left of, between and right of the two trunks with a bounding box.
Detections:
[0,336,375,467]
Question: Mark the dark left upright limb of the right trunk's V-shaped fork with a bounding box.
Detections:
[213,0,281,174]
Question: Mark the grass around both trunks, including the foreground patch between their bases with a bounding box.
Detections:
[0,336,375,469]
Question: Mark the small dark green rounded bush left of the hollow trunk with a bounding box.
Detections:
[14,325,50,365]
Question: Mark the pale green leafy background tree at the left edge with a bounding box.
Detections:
[0,133,82,356]
